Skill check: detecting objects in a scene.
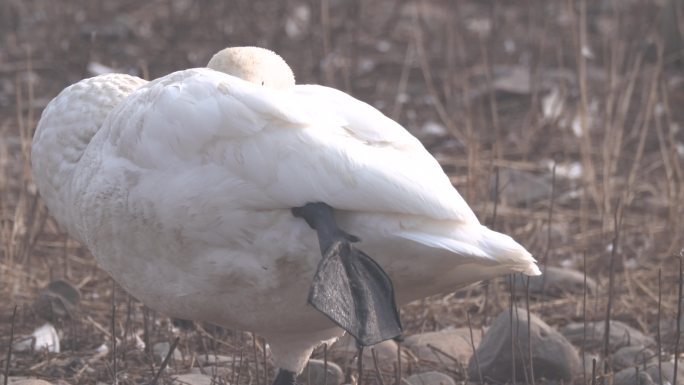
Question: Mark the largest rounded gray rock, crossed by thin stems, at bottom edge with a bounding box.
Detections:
[468,309,582,382]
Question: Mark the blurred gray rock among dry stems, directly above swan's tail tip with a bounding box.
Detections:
[490,168,551,206]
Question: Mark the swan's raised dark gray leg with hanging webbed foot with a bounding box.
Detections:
[292,202,401,346]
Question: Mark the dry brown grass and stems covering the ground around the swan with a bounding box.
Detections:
[0,0,684,384]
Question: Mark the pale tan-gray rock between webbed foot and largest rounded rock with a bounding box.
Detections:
[404,328,481,364]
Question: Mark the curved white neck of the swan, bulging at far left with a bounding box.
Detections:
[31,74,146,239]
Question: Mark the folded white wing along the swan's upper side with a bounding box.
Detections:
[97,69,477,223]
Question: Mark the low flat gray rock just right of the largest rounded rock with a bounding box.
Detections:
[561,321,655,352]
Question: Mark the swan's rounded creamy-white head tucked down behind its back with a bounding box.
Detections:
[207,47,295,90]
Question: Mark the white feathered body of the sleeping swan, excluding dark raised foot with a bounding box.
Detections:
[32,48,540,380]
